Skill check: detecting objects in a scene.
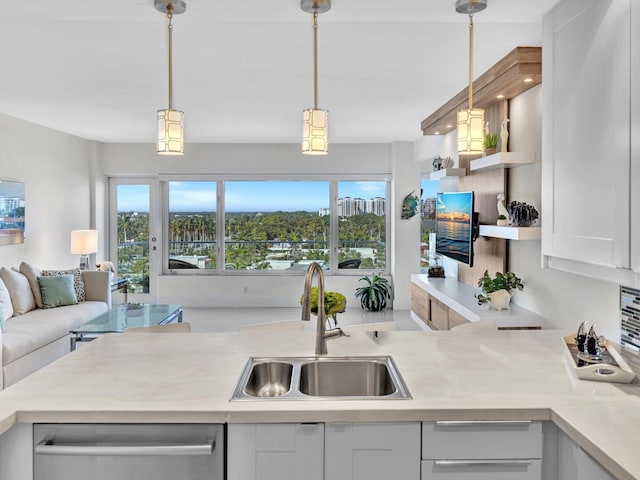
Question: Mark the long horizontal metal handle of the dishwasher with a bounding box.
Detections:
[34,439,216,456]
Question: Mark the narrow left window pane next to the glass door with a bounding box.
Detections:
[168,181,217,270]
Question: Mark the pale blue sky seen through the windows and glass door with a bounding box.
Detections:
[118,181,388,212]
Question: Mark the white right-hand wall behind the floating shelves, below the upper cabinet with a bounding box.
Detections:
[508,86,620,342]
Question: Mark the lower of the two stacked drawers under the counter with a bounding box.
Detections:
[420,459,542,480]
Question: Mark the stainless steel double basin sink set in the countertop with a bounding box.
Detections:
[231,356,411,400]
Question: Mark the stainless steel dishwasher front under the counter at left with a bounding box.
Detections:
[33,424,224,480]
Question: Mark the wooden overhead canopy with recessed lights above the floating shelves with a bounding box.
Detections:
[420,47,542,135]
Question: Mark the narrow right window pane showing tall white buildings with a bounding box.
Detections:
[337,181,387,269]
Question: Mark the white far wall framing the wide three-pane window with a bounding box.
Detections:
[101,142,421,309]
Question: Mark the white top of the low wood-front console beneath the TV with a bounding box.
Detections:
[411,274,544,328]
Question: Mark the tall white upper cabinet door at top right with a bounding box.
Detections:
[542,0,631,269]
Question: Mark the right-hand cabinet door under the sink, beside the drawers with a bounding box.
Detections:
[324,423,420,480]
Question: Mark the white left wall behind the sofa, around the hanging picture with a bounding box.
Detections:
[0,114,104,268]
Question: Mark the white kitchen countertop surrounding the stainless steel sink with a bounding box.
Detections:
[0,329,640,479]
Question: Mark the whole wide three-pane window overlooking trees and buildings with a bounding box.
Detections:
[164,179,388,274]
